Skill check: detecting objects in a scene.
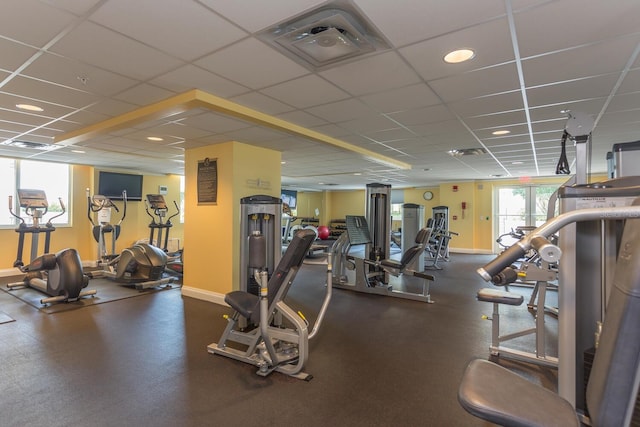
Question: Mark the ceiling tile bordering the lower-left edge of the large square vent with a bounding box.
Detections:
[196,38,309,89]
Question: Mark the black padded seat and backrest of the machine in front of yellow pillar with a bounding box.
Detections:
[224,229,316,323]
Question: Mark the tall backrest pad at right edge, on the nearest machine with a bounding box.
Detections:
[587,212,640,426]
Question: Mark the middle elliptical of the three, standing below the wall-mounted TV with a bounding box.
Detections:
[87,189,174,290]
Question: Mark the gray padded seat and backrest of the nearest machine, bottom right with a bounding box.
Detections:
[458,213,640,427]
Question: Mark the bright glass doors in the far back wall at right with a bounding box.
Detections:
[494,185,558,252]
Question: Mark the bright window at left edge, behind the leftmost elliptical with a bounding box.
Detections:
[0,159,71,228]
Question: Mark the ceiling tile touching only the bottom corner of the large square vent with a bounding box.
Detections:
[261,75,348,108]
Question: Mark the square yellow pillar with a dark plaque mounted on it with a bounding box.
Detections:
[183,142,281,300]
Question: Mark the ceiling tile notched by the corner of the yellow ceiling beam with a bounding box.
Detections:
[150,64,248,97]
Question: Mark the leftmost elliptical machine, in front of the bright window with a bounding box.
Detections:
[7,189,97,305]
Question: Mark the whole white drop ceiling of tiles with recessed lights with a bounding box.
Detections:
[0,0,640,190]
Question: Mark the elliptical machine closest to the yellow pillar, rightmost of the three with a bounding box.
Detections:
[144,194,184,277]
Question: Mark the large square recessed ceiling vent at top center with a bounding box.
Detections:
[258,1,389,70]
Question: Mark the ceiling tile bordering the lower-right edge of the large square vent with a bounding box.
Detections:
[319,52,420,96]
